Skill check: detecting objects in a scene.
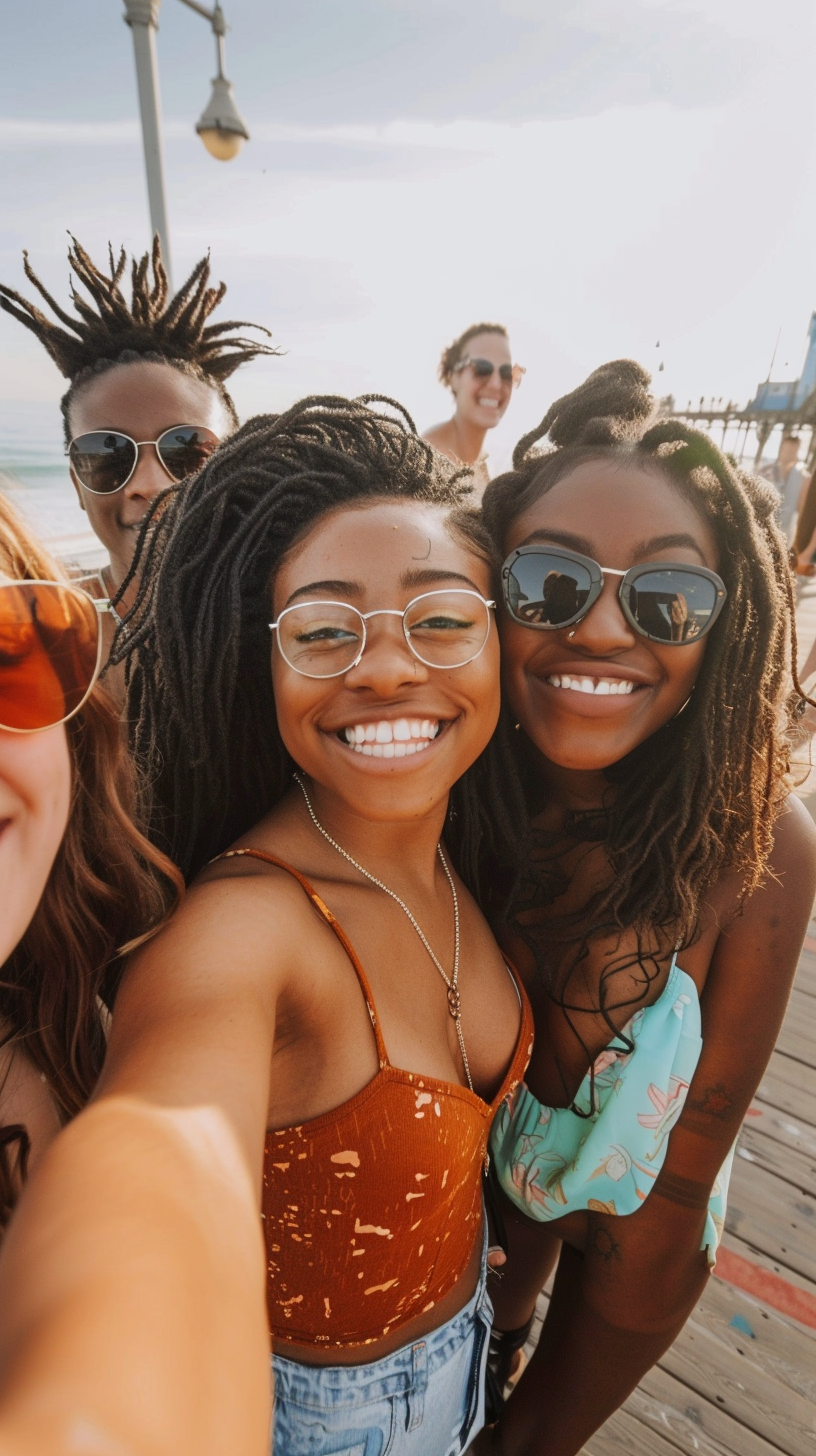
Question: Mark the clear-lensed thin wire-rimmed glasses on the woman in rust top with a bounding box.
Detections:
[270,590,495,677]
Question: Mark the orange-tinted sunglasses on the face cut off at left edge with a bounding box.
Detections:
[0,581,109,732]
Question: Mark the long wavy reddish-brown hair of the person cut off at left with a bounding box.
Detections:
[0,494,182,1227]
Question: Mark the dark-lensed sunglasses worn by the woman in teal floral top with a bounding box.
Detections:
[501,546,727,646]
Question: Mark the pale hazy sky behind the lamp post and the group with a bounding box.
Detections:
[0,0,816,463]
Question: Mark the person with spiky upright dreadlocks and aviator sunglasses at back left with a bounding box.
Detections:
[0,236,277,631]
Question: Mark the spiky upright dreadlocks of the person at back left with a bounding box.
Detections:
[0,234,278,444]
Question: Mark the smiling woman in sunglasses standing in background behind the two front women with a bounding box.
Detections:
[424,323,525,495]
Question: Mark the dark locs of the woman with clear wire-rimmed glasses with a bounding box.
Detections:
[112,396,521,884]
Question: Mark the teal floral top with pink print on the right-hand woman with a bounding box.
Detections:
[491,960,734,1267]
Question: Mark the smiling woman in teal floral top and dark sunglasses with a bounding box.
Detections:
[475,361,816,1456]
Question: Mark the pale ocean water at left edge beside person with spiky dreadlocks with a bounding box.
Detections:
[0,400,105,566]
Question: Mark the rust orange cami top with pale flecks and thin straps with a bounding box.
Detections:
[220,849,533,1347]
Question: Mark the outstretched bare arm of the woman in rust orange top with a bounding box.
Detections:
[0,881,284,1456]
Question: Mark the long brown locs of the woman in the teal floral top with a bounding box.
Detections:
[482,360,799,1042]
